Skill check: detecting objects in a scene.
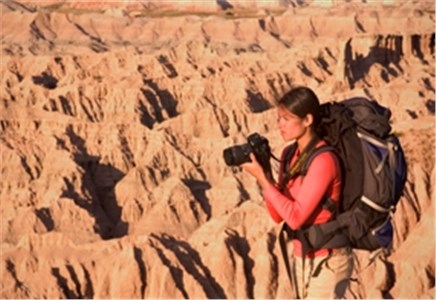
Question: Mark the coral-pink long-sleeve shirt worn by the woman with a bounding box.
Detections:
[263,141,341,256]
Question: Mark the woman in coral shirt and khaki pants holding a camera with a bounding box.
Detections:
[242,87,353,299]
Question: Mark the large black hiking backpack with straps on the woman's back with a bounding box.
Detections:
[281,98,407,253]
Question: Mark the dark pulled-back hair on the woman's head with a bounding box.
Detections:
[278,86,320,128]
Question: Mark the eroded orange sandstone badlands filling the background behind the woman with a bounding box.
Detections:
[0,0,435,299]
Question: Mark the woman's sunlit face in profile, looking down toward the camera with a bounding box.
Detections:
[277,106,310,142]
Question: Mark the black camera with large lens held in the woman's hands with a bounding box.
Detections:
[223,133,271,172]
